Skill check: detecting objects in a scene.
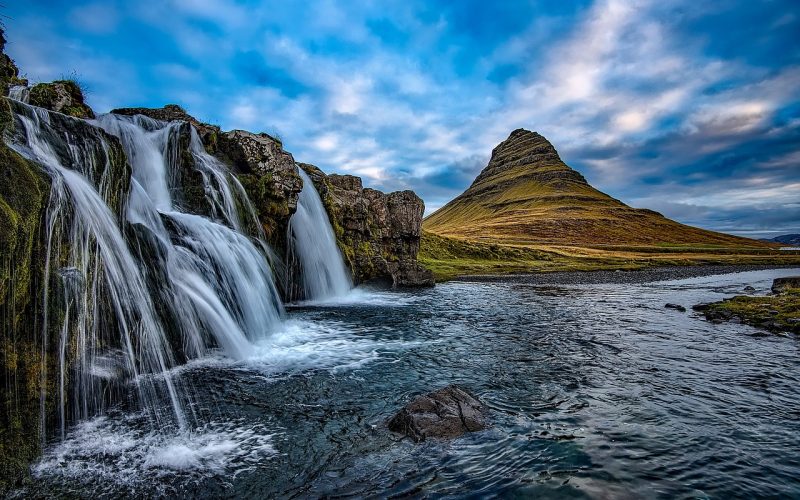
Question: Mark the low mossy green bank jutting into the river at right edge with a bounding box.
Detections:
[705,288,800,334]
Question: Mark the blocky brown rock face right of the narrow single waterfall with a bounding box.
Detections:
[300,163,434,287]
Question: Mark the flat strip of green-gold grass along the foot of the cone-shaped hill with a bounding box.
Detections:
[419,231,800,282]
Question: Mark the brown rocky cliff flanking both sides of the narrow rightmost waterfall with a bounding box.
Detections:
[112,104,433,287]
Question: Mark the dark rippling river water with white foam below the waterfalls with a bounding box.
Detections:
[16,269,800,498]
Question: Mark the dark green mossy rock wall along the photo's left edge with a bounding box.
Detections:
[0,136,48,494]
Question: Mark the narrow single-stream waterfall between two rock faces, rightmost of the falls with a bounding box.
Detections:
[289,168,353,300]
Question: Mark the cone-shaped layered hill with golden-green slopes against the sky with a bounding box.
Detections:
[423,129,768,248]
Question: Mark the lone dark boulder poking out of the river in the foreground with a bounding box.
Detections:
[388,385,487,442]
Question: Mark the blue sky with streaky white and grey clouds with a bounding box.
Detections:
[6,0,800,237]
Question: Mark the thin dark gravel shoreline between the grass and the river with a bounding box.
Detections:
[453,265,798,285]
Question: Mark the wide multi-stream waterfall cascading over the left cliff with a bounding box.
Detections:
[6,101,284,435]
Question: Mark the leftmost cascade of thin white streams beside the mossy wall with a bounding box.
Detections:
[12,106,185,437]
